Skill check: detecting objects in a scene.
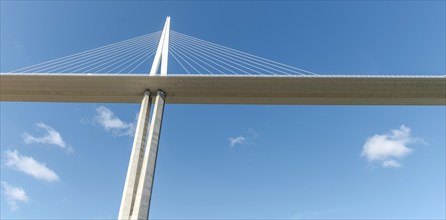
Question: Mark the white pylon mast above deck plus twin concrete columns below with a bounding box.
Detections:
[118,17,170,220]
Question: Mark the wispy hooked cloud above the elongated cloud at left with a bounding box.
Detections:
[23,122,73,151]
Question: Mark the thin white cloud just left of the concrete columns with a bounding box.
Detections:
[94,106,135,136]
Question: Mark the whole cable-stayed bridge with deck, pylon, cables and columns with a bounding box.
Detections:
[0,18,446,219]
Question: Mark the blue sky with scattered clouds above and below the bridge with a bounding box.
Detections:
[0,1,446,219]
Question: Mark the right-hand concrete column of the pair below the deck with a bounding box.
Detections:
[130,91,166,220]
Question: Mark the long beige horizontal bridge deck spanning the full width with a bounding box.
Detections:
[0,74,446,105]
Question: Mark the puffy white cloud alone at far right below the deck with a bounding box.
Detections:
[361,125,425,168]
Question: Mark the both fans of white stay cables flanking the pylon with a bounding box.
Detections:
[6,31,316,76]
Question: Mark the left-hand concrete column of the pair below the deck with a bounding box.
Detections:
[118,90,151,220]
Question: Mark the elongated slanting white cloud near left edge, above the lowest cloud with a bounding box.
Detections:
[5,150,59,182]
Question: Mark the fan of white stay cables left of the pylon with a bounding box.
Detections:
[10,31,161,73]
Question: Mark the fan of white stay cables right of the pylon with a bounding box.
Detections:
[169,31,316,75]
